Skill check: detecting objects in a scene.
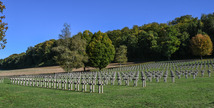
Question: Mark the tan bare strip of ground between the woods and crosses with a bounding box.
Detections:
[0,62,139,76]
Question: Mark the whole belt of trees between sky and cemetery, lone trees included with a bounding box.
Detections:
[0,13,214,71]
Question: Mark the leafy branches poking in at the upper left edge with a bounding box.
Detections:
[0,1,8,49]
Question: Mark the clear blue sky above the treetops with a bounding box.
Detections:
[0,0,214,59]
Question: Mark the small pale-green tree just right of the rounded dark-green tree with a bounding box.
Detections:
[115,45,128,66]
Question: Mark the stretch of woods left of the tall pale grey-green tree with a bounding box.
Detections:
[0,39,57,69]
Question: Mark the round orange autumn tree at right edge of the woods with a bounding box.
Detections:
[190,34,213,59]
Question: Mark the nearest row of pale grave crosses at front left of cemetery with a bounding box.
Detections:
[10,77,103,93]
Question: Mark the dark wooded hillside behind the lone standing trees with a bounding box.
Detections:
[0,13,214,69]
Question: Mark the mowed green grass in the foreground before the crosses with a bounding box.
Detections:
[0,77,214,108]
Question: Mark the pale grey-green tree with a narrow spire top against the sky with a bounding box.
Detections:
[53,24,87,72]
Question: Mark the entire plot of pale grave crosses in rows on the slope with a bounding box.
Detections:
[8,60,214,93]
